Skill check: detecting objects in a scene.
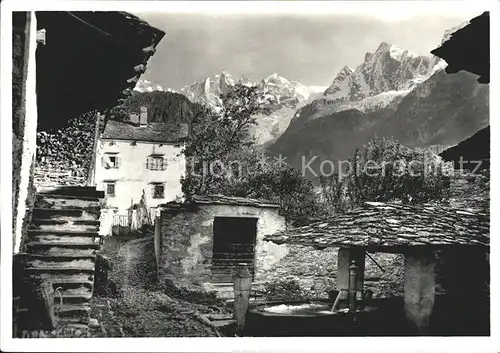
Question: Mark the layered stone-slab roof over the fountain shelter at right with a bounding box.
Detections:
[266,202,489,252]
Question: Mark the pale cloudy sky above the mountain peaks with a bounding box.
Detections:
[134,10,482,90]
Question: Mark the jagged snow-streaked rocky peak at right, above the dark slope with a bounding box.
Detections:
[293,42,446,121]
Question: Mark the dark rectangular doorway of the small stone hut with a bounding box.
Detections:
[212,217,257,283]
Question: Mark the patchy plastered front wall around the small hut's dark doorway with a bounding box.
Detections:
[155,205,287,285]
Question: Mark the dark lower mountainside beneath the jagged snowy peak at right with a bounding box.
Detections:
[270,71,489,173]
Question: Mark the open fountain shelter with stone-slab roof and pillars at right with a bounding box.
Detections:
[265,202,490,335]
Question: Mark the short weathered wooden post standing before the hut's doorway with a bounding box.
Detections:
[233,264,252,333]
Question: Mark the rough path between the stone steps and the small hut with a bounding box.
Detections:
[91,237,228,337]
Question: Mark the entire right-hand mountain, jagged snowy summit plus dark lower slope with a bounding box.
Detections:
[270,25,489,173]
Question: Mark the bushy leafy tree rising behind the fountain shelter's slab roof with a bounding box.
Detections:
[323,138,450,211]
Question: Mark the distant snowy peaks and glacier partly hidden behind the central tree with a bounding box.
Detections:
[181,71,325,144]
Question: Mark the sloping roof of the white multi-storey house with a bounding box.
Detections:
[101,120,188,143]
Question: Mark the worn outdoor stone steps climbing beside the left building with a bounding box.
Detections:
[24,187,104,326]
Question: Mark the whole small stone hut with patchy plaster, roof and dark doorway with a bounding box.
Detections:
[155,195,287,295]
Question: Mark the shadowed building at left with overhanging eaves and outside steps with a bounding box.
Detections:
[10,11,165,337]
